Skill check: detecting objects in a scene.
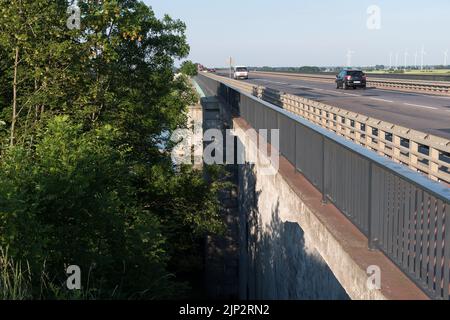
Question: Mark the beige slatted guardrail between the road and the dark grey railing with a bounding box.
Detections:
[208,74,450,184]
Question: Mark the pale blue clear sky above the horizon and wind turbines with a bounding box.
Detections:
[144,0,450,67]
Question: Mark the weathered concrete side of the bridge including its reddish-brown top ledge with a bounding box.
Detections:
[233,118,427,299]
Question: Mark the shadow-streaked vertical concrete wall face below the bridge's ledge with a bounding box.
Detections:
[238,123,349,300]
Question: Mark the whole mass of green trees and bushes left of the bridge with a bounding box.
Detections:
[0,0,222,299]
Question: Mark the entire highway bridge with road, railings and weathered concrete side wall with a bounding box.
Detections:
[195,72,450,300]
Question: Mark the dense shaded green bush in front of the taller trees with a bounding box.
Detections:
[0,117,178,298]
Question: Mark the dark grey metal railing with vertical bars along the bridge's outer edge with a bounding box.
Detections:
[200,75,450,300]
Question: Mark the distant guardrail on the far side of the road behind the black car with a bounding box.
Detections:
[253,71,450,95]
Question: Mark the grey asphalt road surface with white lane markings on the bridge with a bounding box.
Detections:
[218,72,450,139]
